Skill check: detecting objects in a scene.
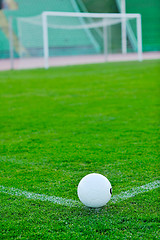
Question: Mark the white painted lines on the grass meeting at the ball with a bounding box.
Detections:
[0,180,160,207]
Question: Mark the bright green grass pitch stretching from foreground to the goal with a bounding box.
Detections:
[0,61,160,240]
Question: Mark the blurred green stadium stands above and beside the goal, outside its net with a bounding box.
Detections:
[0,0,160,59]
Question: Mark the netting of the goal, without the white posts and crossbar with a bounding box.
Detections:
[18,15,137,68]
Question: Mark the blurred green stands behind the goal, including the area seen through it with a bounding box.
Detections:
[0,0,160,68]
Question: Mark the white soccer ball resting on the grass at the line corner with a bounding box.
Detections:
[77,173,112,208]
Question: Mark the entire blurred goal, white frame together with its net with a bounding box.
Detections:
[18,12,142,68]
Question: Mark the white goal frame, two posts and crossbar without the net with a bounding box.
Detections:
[42,11,142,69]
